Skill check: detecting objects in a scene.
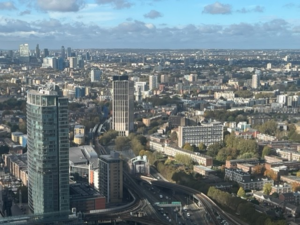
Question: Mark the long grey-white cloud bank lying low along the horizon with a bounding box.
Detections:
[0,17,300,48]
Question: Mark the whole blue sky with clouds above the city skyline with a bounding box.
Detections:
[0,0,300,49]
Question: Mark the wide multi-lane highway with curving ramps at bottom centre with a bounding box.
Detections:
[94,130,247,225]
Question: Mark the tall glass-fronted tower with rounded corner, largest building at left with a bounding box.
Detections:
[26,84,69,214]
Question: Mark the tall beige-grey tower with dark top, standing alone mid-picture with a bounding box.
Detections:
[112,76,134,136]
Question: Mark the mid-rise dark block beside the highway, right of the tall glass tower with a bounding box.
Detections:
[99,151,123,203]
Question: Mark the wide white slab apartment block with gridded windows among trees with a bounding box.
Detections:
[178,122,223,147]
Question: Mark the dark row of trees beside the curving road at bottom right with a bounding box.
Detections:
[207,187,287,225]
